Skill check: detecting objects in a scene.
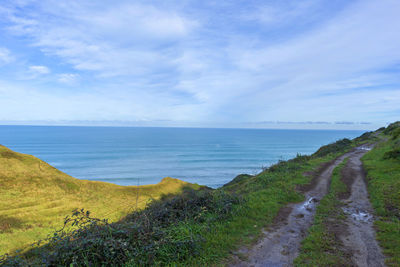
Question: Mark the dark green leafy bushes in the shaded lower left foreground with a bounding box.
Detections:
[0,189,240,266]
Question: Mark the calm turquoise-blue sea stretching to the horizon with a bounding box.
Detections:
[0,126,362,187]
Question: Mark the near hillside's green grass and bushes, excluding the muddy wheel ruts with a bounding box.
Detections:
[0,124,400,266]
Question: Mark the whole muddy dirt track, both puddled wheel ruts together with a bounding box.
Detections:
[230,147,384,267]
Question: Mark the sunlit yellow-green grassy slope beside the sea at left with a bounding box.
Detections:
[0,146,197,255]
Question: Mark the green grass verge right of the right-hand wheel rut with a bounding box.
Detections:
[362,134,400,266]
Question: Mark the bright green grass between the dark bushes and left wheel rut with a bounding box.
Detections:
[178,153,350,266]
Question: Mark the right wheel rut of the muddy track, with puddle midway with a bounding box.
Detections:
[340,148,385,267]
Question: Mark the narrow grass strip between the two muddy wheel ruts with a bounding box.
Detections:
[294,159,351,266]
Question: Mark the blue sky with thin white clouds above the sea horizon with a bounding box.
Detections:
[0,0,400,129]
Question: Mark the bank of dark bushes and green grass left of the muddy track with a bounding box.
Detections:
[0,136,353,266]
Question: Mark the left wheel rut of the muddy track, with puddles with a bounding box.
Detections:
[231,151,357,267]
